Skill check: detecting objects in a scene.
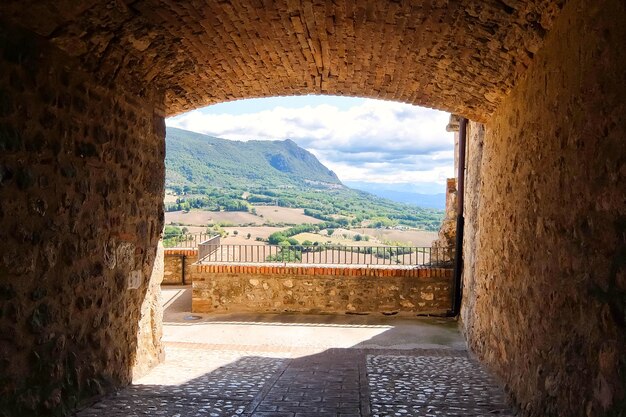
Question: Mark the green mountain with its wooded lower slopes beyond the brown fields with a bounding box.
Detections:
[165,128,443,230]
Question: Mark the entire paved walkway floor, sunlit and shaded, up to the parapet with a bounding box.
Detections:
[76,286,513,417]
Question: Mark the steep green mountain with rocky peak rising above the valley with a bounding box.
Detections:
[165,127,342,188]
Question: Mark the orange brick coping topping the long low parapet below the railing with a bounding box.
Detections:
[194,263,453,278]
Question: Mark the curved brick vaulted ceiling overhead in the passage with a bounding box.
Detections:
[0,0,565,121]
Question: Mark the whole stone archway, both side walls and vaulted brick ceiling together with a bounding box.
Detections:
[0,0,626,416]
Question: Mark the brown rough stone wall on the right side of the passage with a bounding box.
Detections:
[463,0,626,417]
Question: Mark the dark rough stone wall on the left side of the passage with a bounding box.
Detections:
[0,24,165,417]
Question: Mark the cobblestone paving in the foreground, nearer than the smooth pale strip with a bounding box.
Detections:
[76,344,513,417]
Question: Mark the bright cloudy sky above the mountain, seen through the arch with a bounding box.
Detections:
[166,96,454,193]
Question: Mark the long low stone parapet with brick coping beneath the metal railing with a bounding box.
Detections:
[192,265,452,314]
